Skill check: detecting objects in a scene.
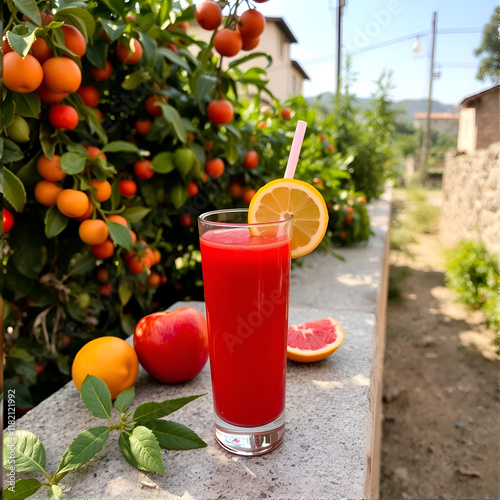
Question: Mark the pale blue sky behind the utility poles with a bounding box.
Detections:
[236,0,499,105]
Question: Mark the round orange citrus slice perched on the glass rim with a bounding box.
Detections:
[248,179,328,259]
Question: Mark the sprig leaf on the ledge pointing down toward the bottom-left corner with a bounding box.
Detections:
[57,428,109,474]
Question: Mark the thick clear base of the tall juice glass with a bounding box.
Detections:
[215,412,285,457]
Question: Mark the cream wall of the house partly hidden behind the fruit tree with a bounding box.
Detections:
[189,22,304,101]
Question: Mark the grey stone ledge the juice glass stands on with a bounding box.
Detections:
[5,186,390,500]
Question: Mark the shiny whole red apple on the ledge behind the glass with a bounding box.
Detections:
[134,307,208,384]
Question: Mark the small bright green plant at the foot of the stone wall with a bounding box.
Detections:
[446,241,500,346]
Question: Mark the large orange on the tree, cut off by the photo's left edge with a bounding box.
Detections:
[3,52,44,94]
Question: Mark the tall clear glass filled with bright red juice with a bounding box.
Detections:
[198,209,292,456]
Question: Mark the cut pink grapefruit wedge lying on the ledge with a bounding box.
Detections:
[287,316,344,363]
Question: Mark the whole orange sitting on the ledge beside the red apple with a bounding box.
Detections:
[71,337,139,399]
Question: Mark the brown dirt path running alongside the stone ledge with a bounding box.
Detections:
[381,189,500,499]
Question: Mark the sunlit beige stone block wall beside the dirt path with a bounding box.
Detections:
[440,143,500,253]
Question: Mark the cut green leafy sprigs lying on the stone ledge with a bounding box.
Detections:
[3,375,206,500]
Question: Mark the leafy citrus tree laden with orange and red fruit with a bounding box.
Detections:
[1,0,380,409]
